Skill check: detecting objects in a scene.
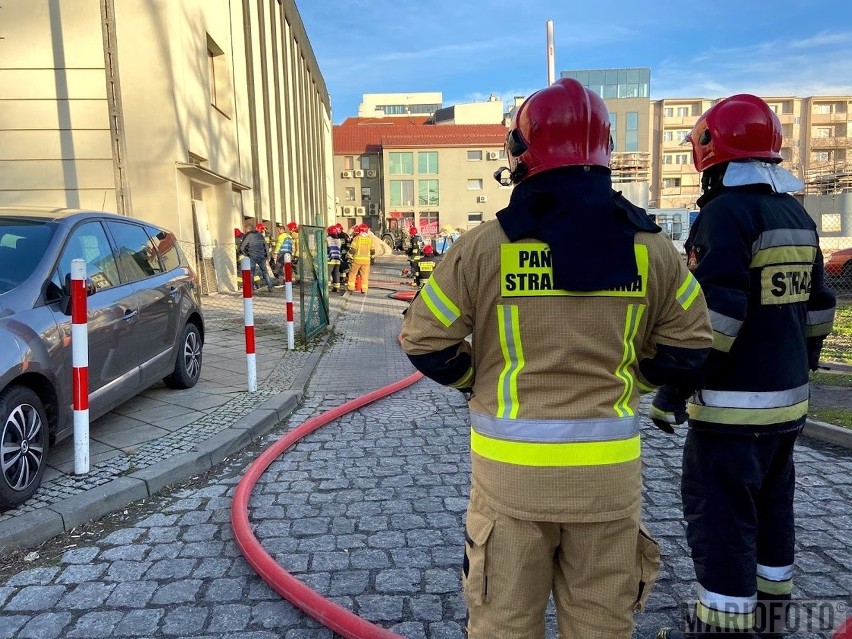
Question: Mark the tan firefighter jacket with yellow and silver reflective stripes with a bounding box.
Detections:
[400,221,712,522]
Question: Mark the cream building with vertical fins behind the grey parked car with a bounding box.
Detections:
[0,0,334,292]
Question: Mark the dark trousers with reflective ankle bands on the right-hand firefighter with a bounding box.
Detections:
[681,426,798,638]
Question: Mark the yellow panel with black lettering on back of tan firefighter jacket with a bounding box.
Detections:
[500,242,648,297]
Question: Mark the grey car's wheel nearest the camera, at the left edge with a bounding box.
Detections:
[0,386,50,511]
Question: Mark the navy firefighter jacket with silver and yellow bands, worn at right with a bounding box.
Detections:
[685,184,835,433]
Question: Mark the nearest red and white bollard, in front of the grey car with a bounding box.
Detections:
[71,260,89,475]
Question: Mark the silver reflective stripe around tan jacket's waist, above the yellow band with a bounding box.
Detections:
[470,411,640,444]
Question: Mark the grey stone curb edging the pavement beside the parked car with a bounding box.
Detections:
[0,391,302,557]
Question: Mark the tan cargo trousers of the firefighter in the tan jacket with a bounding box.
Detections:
[462,488,660,639]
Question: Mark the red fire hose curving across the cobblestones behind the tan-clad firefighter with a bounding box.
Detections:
[231,373,423,639]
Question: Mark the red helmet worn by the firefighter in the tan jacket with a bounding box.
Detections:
[506,78,612,184]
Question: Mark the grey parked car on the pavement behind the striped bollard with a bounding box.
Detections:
[0,208,204,511]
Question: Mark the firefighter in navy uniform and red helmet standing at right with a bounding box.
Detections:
[652,94,835,639]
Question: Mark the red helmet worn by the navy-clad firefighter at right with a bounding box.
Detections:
[687,93,782,172]
